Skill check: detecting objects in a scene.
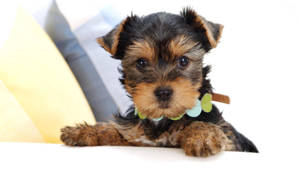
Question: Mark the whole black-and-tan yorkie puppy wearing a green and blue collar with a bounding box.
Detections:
[61,8,258,157]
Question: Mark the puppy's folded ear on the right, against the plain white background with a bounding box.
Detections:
[180,8,223,50]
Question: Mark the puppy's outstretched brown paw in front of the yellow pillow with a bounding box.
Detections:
[60,123,99,146]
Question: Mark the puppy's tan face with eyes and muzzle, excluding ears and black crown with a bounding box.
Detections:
[122,34,205,118]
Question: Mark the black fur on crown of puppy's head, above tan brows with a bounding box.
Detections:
[113,12,211,59]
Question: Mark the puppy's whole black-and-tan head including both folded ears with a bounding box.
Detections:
[98,9,222,118]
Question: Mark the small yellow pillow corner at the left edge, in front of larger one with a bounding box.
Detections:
[0,80,44,142]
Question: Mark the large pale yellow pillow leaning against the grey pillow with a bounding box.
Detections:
[0,8,95,143]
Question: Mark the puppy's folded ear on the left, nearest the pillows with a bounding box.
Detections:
[97,17,130,59]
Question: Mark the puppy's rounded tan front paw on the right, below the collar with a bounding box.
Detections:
[181,121,227,157]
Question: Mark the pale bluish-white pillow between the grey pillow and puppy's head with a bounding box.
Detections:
[73,9,132,113]
